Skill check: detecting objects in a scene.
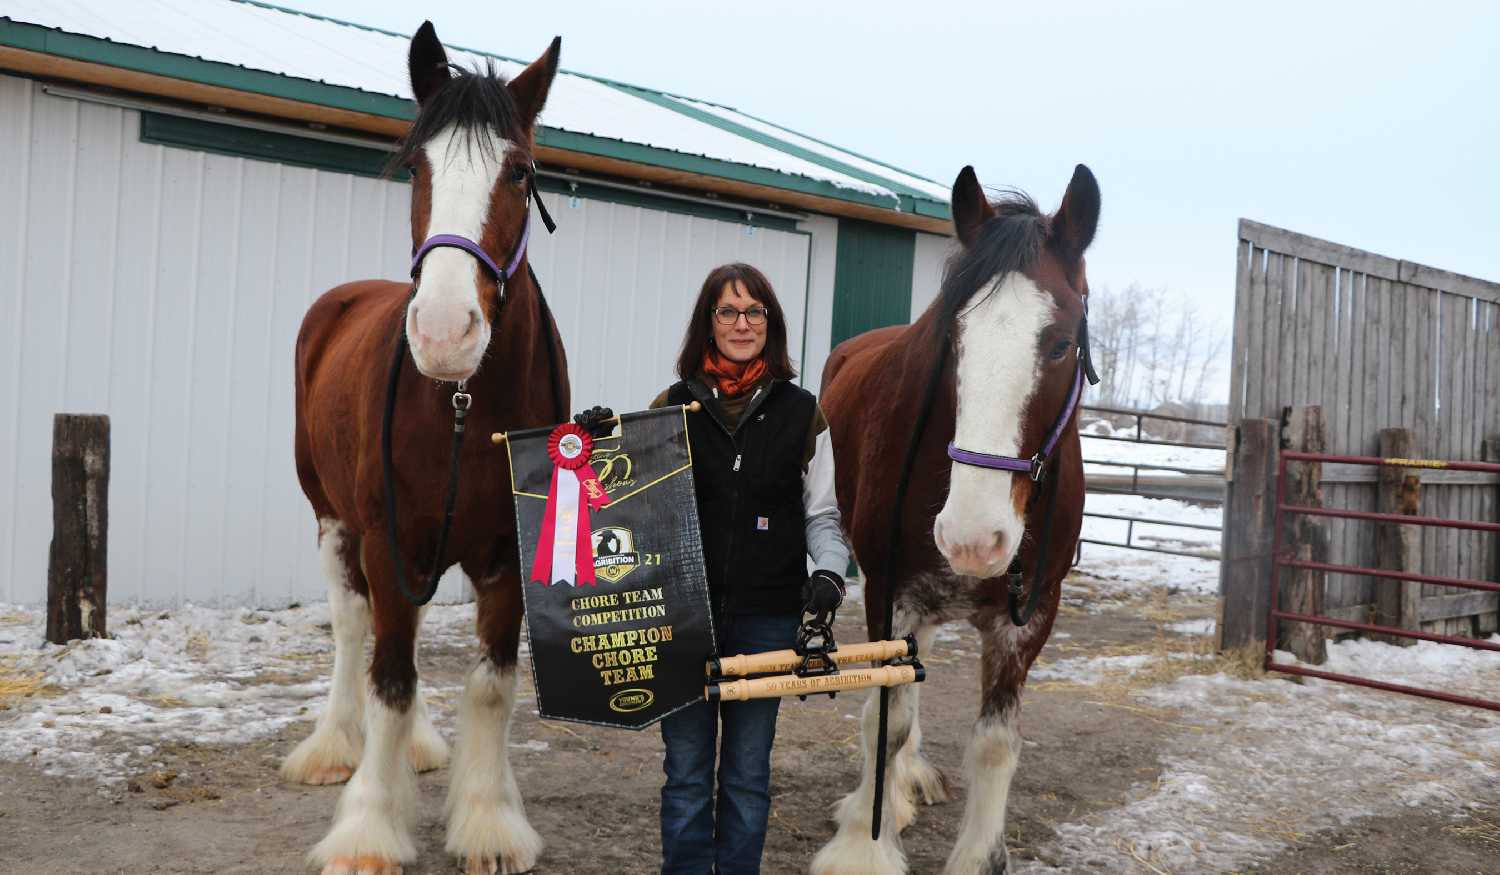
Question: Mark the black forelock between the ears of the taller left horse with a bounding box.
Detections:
[392,60,530,168]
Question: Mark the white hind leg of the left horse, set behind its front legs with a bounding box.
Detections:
[281,518,371,783]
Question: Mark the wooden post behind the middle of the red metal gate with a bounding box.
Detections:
[1376,428,1422,645]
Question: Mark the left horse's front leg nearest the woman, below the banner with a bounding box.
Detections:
[446,569,542,875]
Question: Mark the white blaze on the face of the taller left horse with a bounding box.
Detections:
[407,125,510,380]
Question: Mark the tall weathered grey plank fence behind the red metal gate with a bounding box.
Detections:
[1224,219,1500,635]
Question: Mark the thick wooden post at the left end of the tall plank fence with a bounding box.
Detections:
[1218,419,1277,650]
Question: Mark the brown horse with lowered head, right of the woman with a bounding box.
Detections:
[812,165,1100,875]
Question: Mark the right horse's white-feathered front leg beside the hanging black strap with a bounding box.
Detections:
[809,609,932,875]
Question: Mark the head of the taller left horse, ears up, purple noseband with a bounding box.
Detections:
[398,21,563,381]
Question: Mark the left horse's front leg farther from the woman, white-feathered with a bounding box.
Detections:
[308,533,417,875]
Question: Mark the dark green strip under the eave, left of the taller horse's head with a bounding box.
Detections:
[141,110,408,182]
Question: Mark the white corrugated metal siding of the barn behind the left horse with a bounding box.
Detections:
[0,77,810,606]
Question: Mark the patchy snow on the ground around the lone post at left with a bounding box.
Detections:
[0,603,486,782]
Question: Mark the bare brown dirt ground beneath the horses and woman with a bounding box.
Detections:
[0,576,1500,875]
